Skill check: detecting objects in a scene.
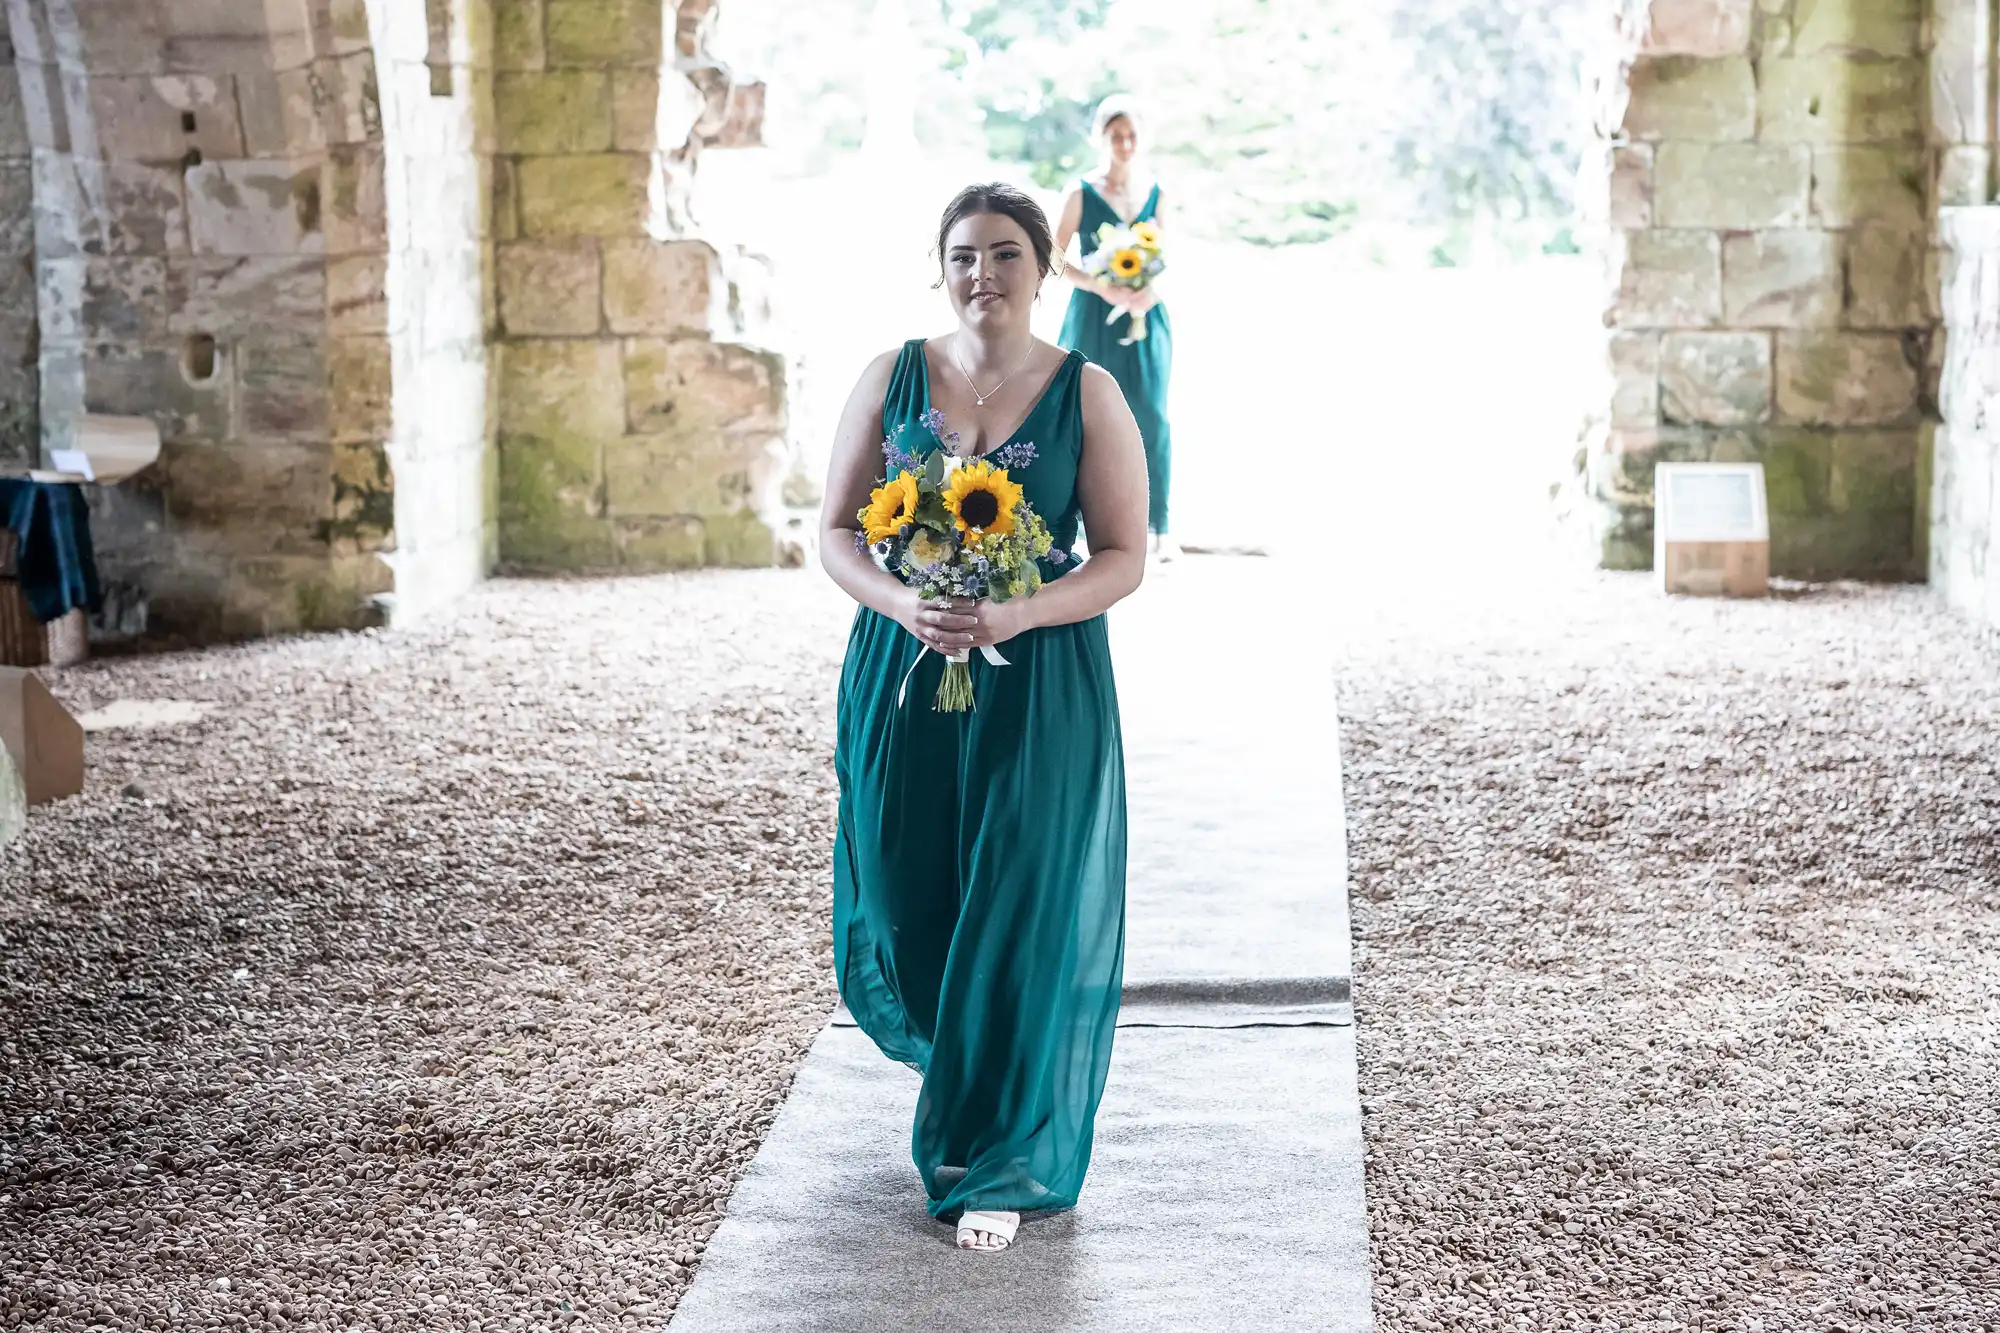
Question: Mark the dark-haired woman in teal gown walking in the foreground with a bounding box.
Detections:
[820,186,1146,1251]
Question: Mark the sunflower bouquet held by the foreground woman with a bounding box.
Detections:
[858,408,1060,713]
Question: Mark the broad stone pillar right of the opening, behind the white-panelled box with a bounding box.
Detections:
[1584,0,1936,578]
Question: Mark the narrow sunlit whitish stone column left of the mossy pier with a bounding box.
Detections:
[366,0,498,624]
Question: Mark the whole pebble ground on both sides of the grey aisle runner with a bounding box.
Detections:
[0,572,2000,1333]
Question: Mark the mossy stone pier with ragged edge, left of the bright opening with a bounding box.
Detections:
[494,0,788,568]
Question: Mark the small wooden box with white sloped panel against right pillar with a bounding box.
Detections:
[1652,462,1770,596]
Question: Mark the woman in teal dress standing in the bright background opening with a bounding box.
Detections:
[1056,98,1180,560]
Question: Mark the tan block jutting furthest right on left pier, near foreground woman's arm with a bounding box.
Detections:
[624,338,786,436]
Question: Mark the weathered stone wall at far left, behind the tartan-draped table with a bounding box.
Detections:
[8,0,388,636]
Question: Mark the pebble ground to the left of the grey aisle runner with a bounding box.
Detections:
[0,572,848,1329]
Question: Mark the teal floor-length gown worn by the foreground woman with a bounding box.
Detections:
[834,340,1126,1217]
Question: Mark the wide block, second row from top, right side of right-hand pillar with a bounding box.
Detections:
[1756,56,1924,144]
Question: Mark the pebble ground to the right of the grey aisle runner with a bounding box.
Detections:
[1340,576,2000,1333]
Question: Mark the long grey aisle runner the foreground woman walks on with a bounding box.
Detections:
[670,558,1370,1333]
